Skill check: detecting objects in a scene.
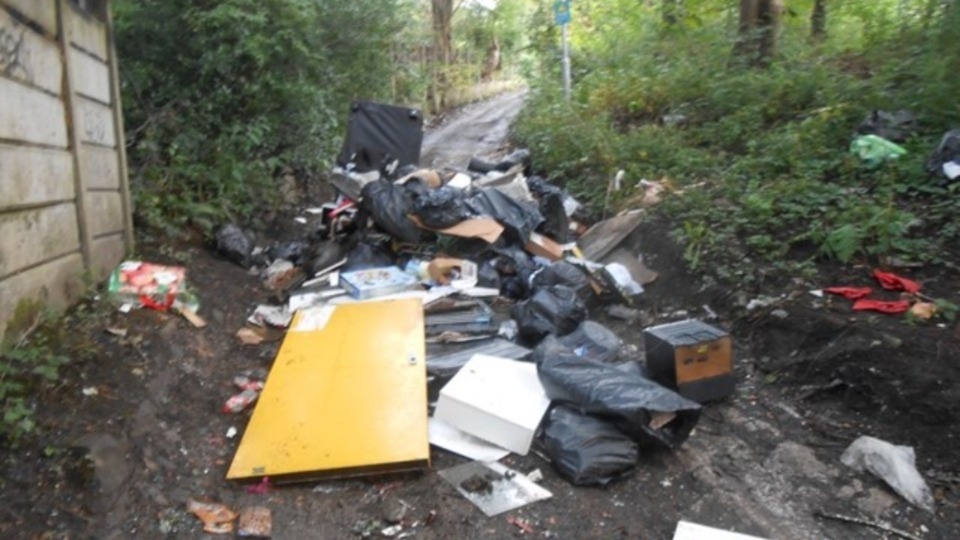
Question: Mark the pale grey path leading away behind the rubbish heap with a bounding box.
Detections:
[420,90,526,168]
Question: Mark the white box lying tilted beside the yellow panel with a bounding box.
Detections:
[434,354,550,455]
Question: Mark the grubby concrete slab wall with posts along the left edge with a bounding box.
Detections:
[0,0,133,336]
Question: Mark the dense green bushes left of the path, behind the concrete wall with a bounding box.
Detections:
[113,0,526,236]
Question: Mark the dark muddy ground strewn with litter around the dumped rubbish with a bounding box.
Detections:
[0,95,960,540]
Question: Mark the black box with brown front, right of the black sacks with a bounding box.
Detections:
[643,319,736,403]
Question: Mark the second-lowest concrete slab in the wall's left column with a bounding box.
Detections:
[0,203,80,276]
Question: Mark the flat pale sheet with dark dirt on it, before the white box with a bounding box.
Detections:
[438,461,553,517]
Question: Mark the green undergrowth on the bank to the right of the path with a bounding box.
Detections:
[516,0,960,282]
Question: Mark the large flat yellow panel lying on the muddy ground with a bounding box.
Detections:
[227,299,430,480]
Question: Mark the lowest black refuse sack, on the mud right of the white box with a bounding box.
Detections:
[543,405,639,486]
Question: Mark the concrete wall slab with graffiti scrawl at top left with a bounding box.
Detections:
[0,10,63,95]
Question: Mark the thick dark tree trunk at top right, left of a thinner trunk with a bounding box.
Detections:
[733,0,783,68]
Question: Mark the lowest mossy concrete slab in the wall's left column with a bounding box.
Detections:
[0,253,84,336]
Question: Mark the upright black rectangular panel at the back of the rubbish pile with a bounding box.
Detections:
[337,101,423,172]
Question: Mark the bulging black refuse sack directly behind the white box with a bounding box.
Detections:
[510,285,587,344]
